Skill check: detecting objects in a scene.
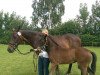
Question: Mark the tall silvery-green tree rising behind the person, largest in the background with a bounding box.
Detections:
[32,0,64,28]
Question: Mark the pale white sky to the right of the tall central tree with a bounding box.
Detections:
[62,0,97,22]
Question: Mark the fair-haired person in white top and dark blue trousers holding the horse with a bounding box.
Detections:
[38,29,50,75]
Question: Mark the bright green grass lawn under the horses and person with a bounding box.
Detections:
[0,45,100,75]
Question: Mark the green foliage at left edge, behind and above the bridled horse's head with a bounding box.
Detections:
[0,11,29,44]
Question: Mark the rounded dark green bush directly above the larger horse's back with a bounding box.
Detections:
[50,20,80,35]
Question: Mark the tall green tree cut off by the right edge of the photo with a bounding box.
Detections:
[89,1,100,36]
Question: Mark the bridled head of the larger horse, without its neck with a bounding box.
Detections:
[7,31,22,53]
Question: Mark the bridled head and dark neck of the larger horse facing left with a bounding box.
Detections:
[7,30,46,53]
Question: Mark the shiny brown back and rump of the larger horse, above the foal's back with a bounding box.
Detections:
[50,34,81,48]
